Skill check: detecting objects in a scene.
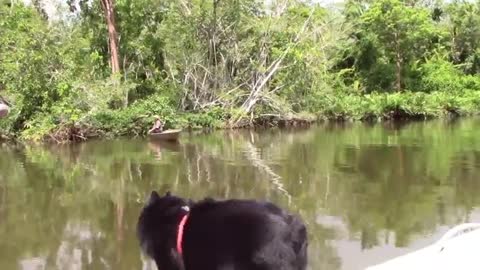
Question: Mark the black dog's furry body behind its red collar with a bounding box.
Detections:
[185,200,308,270]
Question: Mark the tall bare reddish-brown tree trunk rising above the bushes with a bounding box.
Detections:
[100,0,120,74]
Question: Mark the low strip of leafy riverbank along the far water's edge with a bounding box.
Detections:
[0,91,480,143]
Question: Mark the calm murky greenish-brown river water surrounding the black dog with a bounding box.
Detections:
[0,119,480,270]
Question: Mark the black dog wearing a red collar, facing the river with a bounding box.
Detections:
[137,191,308,270]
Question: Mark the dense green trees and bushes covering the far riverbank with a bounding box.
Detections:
[0,0,480,140]
